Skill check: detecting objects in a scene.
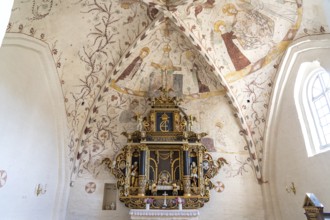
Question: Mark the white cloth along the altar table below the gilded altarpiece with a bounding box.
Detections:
[129,209,199,220]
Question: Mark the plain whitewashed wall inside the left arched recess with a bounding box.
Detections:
[0,34,68,220]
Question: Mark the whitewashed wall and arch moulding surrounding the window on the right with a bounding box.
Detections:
[265,35,330,220]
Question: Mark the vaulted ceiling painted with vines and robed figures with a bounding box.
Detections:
[7,0,302,180]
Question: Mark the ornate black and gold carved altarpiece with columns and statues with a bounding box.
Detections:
[103,91,227,209]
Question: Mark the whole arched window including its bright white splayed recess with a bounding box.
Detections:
[295,61,330,156]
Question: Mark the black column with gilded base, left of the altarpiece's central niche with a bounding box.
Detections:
[138,145,148,196]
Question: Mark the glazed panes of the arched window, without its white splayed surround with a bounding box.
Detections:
[307,69,330,151]
